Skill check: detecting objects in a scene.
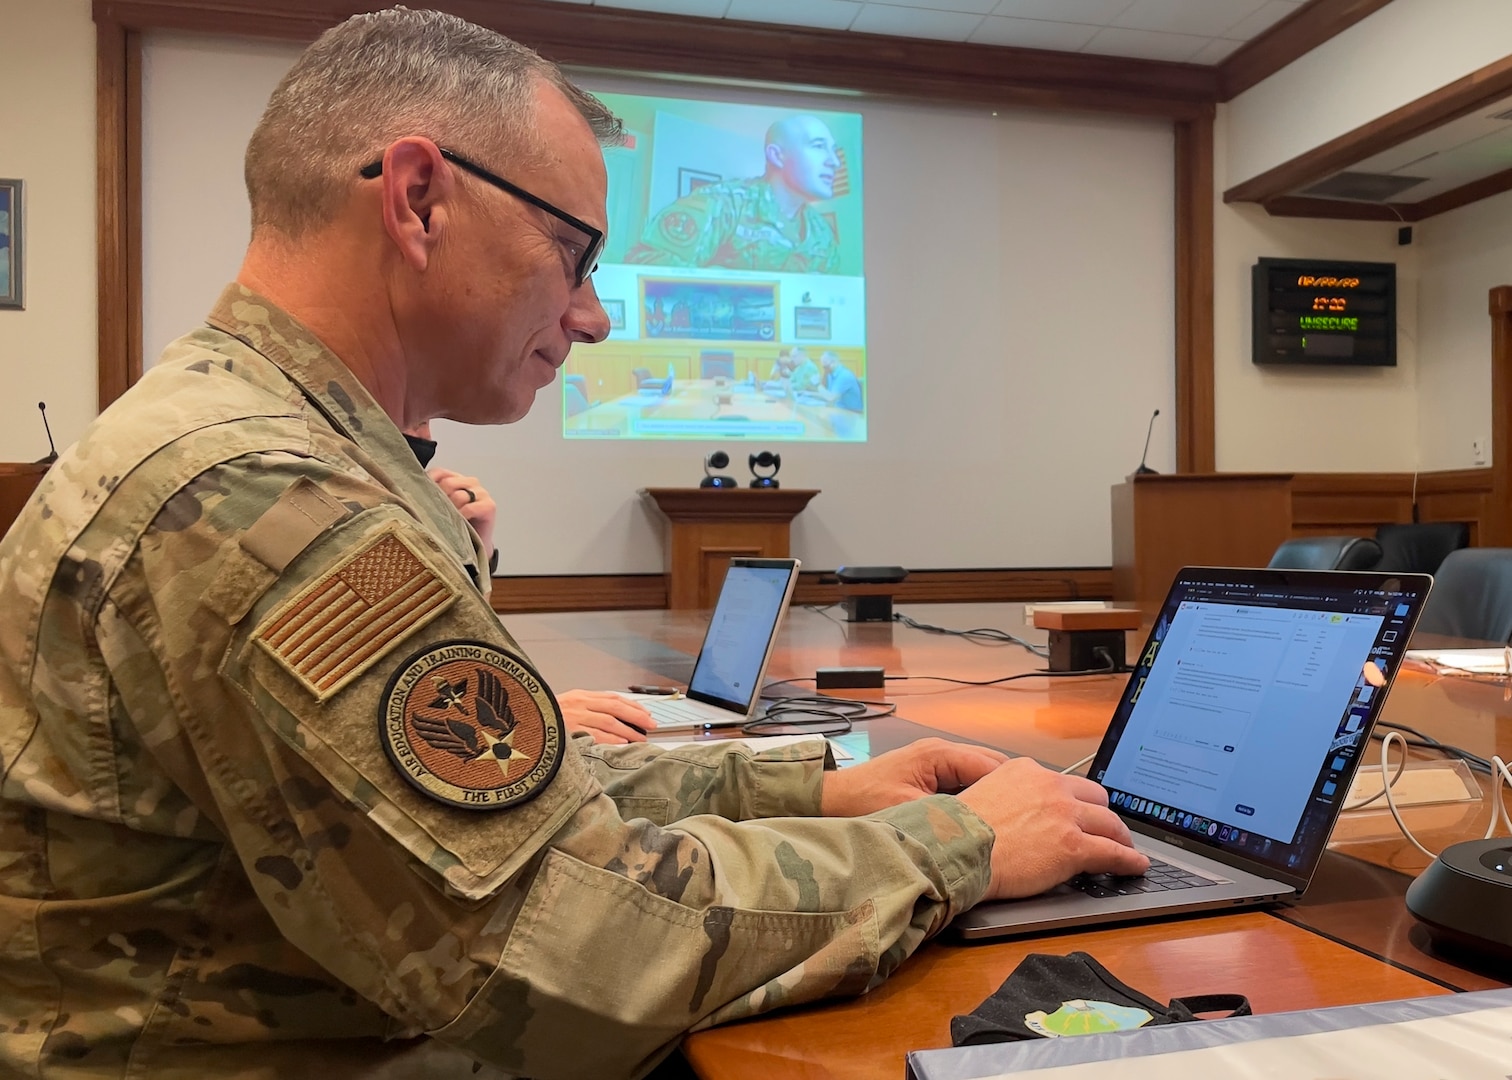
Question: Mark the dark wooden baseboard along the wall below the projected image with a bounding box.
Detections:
[490,567,1113,614]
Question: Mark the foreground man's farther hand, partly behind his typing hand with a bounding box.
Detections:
[820,738,1009,817]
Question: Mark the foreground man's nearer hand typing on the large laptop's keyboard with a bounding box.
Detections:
[957,758,1149,898]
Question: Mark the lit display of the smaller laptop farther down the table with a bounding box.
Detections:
[688,558,797,712]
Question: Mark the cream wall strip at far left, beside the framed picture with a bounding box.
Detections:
[0,0,98,461]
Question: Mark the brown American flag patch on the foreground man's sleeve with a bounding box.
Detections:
[253,528,457,702]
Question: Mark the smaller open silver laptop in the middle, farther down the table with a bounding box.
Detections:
[638,558,798,735]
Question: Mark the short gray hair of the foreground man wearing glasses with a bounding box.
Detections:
[246,8,623,237]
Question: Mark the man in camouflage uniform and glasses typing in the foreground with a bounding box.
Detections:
[0,11,1143,1080]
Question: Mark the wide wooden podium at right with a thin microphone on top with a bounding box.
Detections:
[1113,472,1291,607]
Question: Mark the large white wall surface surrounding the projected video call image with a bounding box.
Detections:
[144,35,1175,573]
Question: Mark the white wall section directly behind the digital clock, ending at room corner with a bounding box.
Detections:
[1213,107,1421,472]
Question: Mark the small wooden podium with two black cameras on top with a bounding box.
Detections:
[641,487,818,608]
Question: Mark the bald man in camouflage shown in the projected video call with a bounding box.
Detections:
[624,115,841,274]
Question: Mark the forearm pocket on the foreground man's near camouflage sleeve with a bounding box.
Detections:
[431,850,878,1075]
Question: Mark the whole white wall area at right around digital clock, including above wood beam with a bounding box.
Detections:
[1214,0,1512,470]
